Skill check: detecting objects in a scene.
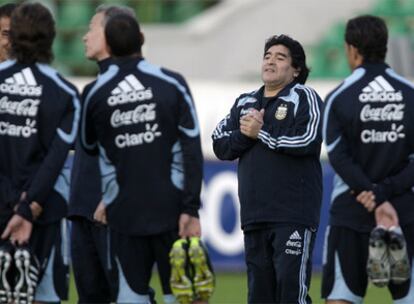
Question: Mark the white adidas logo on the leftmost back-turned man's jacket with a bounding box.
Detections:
[0,68,42,96]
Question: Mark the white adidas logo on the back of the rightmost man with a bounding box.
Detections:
[359,75,403,102]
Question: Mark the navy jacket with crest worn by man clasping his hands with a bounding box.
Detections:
[212,82,322,229]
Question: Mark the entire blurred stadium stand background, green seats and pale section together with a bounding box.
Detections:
[0,0,414,80]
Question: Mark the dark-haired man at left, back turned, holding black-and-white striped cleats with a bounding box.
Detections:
[0,3,80,303]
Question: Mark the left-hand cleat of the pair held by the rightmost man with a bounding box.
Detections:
[367,240,390,287]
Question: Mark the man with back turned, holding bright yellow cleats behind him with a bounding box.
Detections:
[81,15,202,303]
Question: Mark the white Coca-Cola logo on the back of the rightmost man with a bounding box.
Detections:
[360,104,405,122]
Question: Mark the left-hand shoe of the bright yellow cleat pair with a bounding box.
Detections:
[170,239,193,304]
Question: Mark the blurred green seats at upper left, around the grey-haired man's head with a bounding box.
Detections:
[0,0,218,76]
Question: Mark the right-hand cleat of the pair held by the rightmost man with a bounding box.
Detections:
[388,230,411,284]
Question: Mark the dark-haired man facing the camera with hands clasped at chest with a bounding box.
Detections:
[212,35,322,303]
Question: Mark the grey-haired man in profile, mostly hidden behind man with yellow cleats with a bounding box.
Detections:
[69,5,135,303]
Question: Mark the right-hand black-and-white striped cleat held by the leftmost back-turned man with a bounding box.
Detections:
[13,247,40,304]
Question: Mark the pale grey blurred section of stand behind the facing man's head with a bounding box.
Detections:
[144,0,375,81]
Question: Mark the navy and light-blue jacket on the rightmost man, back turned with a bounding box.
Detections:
[323,63,414,231]
